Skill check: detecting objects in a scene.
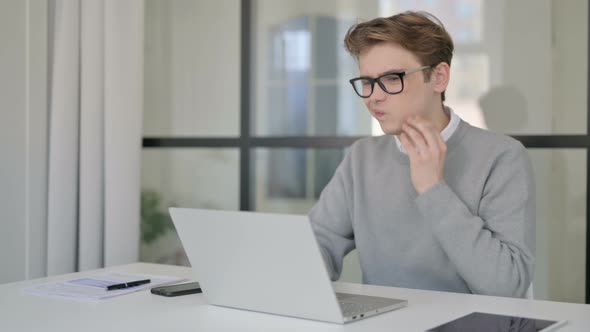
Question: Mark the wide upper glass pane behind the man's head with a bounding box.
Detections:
[252,0,588,136]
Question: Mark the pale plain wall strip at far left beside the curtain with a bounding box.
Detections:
[0,0,47,283]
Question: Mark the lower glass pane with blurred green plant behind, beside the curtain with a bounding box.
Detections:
[140,148,239,265]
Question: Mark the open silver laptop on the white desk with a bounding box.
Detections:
[170,208,407,324]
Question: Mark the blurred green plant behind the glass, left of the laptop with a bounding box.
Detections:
[140,190,175,244]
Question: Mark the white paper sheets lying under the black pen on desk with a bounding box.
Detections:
[23,273,184,301]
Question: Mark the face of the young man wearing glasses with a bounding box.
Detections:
[359,43,435,135]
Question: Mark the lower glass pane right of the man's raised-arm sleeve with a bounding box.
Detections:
[529,149,587,303]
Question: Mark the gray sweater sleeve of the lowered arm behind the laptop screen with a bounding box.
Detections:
[309,148,355,280]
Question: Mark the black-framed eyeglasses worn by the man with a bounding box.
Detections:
[349,66,430,98]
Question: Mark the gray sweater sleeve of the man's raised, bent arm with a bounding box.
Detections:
[416,143,535,297]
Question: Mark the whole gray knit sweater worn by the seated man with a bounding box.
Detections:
[310,121,535,297]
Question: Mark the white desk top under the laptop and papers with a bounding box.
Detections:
[0,263,590,332]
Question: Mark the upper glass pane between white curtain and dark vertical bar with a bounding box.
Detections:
[143,0,241,137]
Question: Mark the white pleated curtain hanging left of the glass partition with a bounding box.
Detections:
[47,0,144,275]
